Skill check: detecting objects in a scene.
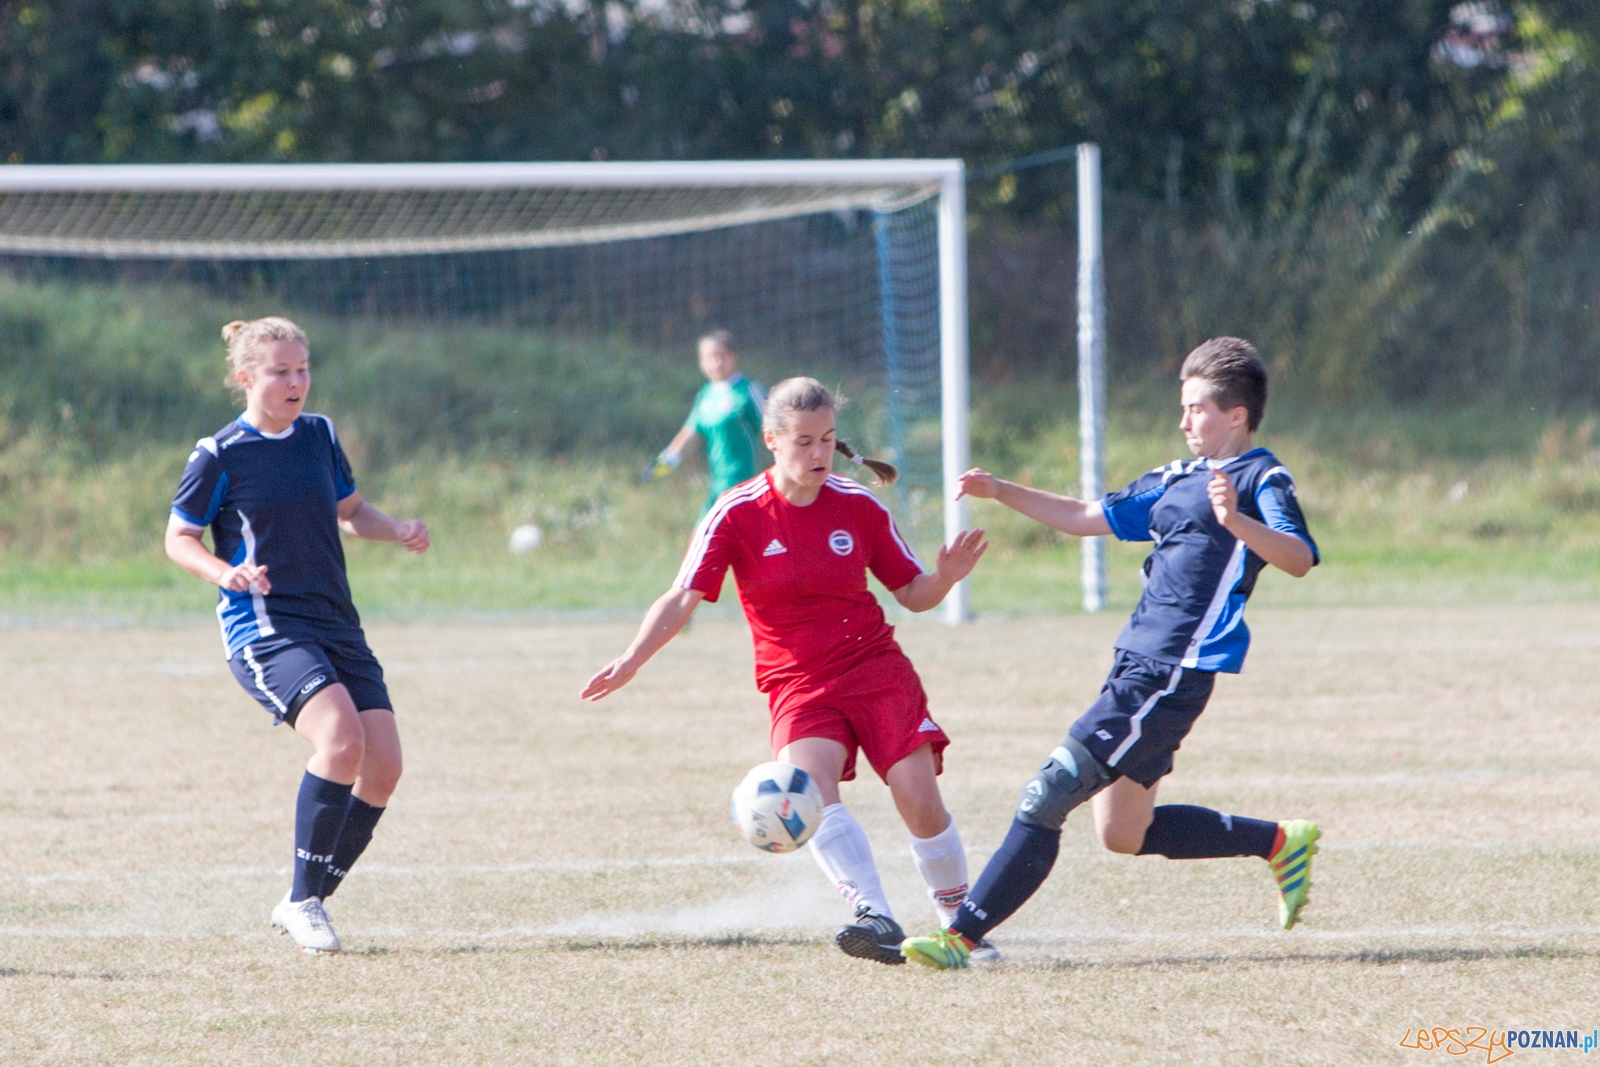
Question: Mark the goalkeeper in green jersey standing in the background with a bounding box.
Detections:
[645,330,766,514]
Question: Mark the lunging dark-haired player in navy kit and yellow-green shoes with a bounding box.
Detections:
[902,338,1320,968]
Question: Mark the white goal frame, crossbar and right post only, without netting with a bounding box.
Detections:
[0,158,971,624]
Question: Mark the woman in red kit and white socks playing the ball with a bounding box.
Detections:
[582,378,989,963]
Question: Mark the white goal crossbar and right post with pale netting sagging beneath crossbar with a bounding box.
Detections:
[0,160,970,622]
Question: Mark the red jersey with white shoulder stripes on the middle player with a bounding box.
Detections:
[674,472,922,693]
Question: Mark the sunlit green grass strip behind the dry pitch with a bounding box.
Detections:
[0,404,1600,617]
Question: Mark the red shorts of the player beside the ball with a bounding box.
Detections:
[768,648,950,782]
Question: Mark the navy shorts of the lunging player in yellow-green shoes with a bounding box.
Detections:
[1067,648,1216,789]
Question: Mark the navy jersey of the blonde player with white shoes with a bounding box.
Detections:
[173,414,362,659]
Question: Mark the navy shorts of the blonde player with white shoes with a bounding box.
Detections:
[227,637,394,726]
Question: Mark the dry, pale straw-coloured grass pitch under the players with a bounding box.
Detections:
[0,605,1600,1064]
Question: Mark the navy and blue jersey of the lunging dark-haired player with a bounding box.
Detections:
[1101,448,1320,673]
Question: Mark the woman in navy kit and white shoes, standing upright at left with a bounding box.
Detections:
[166,318,429,953]
